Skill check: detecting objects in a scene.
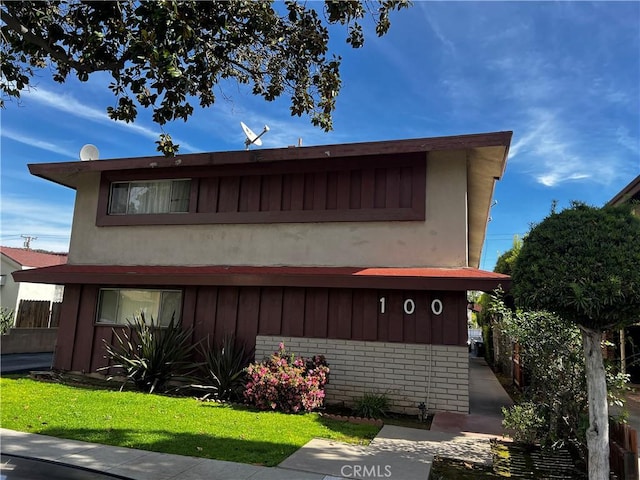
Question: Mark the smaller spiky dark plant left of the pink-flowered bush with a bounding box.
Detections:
[193,335,253,401]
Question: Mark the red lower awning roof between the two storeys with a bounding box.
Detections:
[13,264,511,291]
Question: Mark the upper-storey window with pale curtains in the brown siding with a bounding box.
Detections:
[109,179,191,215]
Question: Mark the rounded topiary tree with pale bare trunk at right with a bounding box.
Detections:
[512,203,640,480]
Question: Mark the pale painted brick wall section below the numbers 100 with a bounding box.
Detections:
[256,335,469,415]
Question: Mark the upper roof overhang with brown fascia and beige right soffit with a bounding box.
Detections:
[29,131,513,267]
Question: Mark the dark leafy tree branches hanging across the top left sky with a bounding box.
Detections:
[0,0,409,155]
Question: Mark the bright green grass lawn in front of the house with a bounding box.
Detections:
[0,378,379,466]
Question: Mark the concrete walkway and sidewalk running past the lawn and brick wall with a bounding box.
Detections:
[0,358,510,480]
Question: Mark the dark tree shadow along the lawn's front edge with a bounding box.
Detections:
[33,428,299,467]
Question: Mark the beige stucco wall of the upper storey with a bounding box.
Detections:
[68,151,467,267]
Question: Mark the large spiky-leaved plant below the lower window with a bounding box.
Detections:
[101,313,197,393]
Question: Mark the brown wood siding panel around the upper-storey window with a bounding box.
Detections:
[96,153,426,226]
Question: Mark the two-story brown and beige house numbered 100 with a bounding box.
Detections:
[15,132,512,413]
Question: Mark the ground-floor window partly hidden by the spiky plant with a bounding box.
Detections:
[98,288,182,326]
